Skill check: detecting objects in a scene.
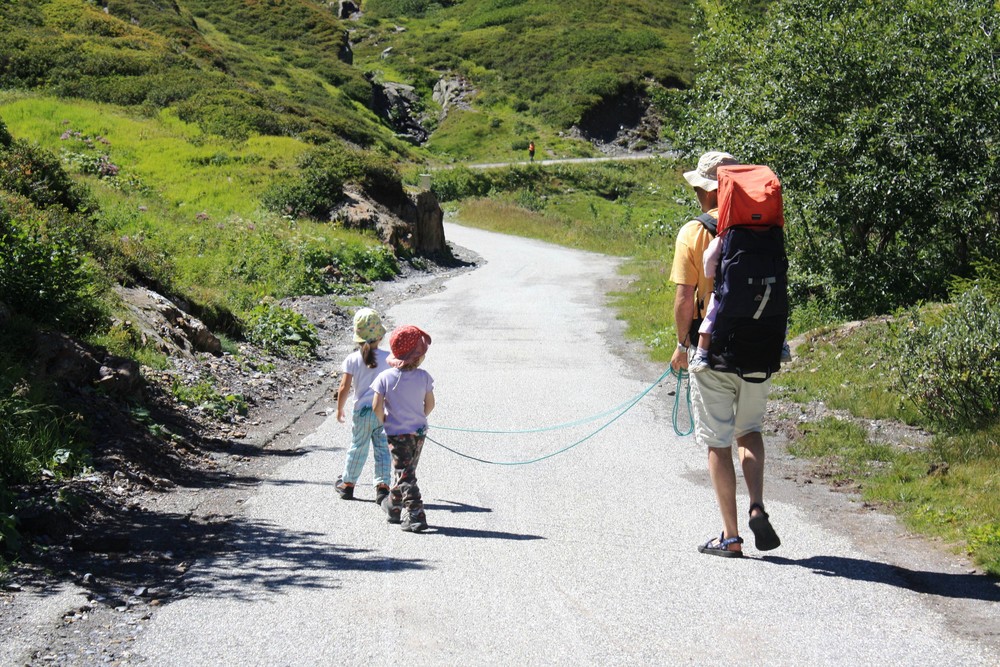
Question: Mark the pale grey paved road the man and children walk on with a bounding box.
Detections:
[132,225,1000,666]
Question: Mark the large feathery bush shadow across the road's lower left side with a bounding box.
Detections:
[20,509,427,607]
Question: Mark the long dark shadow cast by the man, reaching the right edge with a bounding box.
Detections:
[761,556,1000,602]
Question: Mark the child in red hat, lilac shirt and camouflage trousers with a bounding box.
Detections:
[372,324,434,533]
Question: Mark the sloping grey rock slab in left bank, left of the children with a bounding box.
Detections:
[117,287,222,358]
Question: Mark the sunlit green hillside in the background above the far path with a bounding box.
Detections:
[352,0,693,161]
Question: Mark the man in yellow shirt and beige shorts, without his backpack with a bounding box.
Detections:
[670,152,781,558]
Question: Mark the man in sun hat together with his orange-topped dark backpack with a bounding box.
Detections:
[670,151,788,558]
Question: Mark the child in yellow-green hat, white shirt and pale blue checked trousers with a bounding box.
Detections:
[334,308,390,503]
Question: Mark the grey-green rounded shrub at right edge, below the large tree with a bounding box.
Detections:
[897,286,1000,432]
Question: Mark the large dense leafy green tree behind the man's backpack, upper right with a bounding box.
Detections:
[680,0,1000,316]
